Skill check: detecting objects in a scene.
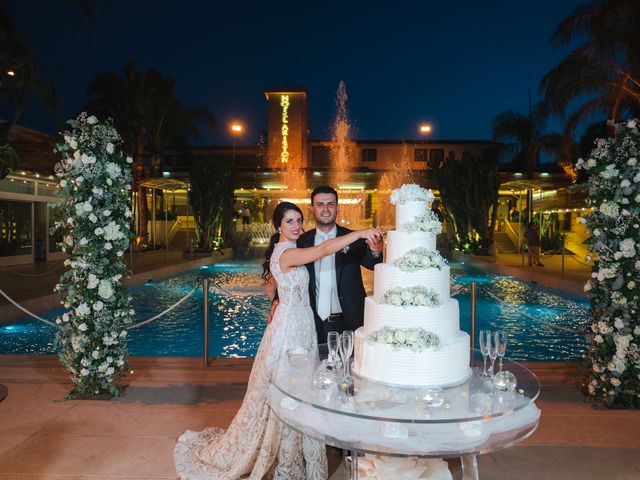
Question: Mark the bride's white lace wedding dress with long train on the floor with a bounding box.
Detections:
[174,242,327,480]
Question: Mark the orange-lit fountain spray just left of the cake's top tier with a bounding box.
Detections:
[375,142,418,230]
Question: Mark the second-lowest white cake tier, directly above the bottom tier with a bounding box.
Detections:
[363,297,460,340]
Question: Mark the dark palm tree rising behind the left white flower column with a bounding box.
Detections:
[86,60,214,246]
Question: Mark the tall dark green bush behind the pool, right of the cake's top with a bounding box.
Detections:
[427,151,500,255]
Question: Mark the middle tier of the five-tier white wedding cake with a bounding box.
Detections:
[373,263,451,303]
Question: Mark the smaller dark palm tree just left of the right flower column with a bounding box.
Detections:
[491,102,575,179]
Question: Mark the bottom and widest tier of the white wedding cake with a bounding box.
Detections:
[354,327,470,387]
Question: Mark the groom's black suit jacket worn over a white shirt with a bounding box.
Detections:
[298,225,382,343]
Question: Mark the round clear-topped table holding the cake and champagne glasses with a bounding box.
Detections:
[269,345,540,480]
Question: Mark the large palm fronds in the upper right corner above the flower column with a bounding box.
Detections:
[540,0,640,141]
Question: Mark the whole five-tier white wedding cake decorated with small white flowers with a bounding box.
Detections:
[354,185,471,386]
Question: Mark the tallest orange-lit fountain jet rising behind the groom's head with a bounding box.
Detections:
[329,81,367,228]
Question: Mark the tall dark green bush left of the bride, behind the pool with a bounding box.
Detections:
[189,157,235,252]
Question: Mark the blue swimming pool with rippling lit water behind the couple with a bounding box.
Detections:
[0,261,590,361]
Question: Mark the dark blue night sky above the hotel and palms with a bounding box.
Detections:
[3,0,584,144]
